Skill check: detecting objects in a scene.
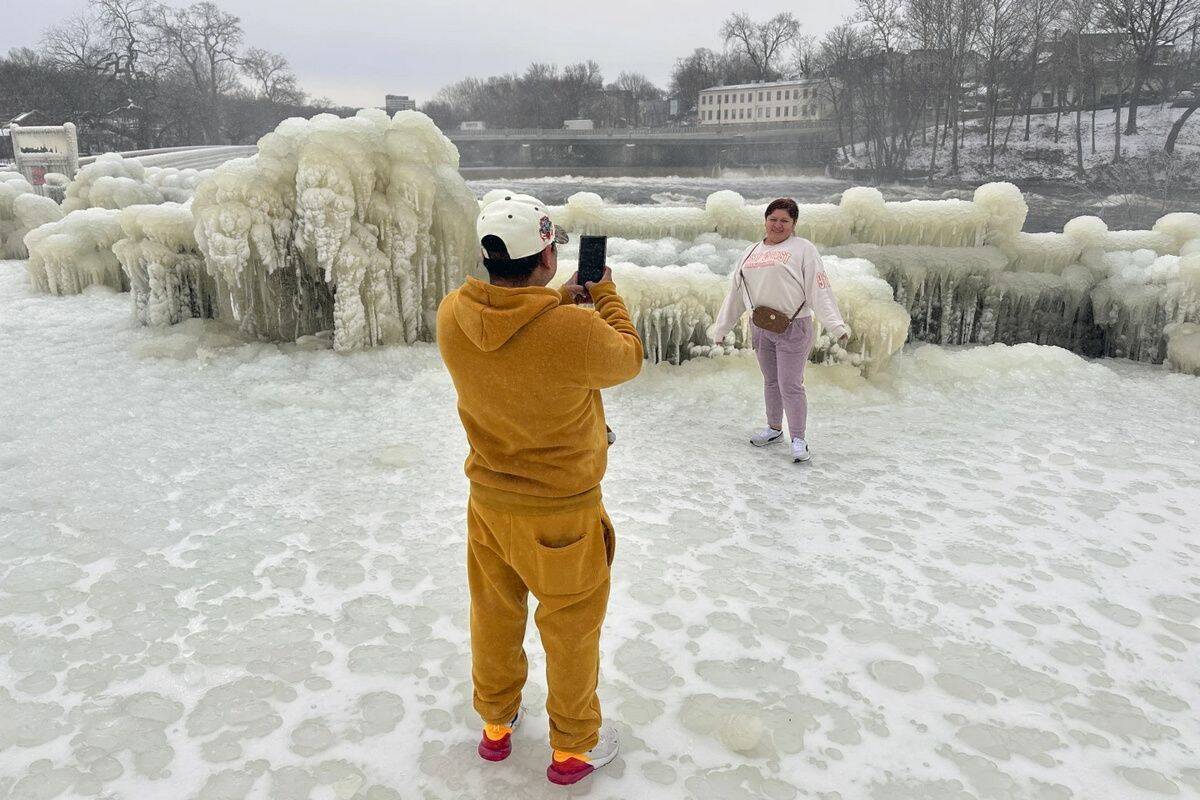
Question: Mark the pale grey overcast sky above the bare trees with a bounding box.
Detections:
[0,0,853,106]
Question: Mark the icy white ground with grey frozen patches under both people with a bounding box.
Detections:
[0,261,1200,800]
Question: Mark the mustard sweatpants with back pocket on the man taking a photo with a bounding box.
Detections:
[467,492,616,752]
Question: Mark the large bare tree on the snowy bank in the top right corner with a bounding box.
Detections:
[1097,0,1200,136]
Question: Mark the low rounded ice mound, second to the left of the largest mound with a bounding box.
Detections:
[25,209,130,295]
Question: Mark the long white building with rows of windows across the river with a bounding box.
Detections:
[696,78,833,125]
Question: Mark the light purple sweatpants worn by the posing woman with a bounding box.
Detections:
[750,317,812,439]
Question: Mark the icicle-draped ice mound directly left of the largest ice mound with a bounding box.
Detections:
[113,203,218,326]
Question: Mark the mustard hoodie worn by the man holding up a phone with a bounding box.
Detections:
[437,277,642,498]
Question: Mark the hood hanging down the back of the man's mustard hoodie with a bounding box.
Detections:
[454,277,560,353]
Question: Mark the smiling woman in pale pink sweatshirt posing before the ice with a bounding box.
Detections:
[713,198,850,462]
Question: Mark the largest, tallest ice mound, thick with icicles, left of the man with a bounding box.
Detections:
[192,109,480,350]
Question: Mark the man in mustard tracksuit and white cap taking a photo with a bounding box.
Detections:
[437,194,642,783]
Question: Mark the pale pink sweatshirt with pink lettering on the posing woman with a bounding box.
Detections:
[713,236,850,342]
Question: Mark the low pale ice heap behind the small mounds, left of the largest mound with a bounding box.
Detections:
[62,152,212,211]
